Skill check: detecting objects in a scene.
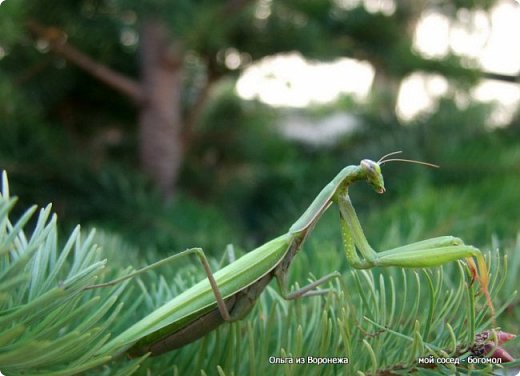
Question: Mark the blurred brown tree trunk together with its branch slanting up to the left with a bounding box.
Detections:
[28,21,183,198]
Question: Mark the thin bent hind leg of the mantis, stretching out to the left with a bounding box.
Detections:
[84,248,231,321]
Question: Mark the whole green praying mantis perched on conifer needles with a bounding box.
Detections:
[87,152,495,357]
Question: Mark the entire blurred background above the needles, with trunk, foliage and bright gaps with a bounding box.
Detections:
[0,0,520,264]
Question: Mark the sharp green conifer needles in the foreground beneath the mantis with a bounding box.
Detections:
[0,175,520,375]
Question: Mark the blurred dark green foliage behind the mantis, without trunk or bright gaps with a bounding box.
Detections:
[0,0,518,252]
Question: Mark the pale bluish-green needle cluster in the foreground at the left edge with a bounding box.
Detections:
[0,174,132,375]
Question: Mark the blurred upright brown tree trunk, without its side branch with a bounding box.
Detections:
[139,21,183,198]
